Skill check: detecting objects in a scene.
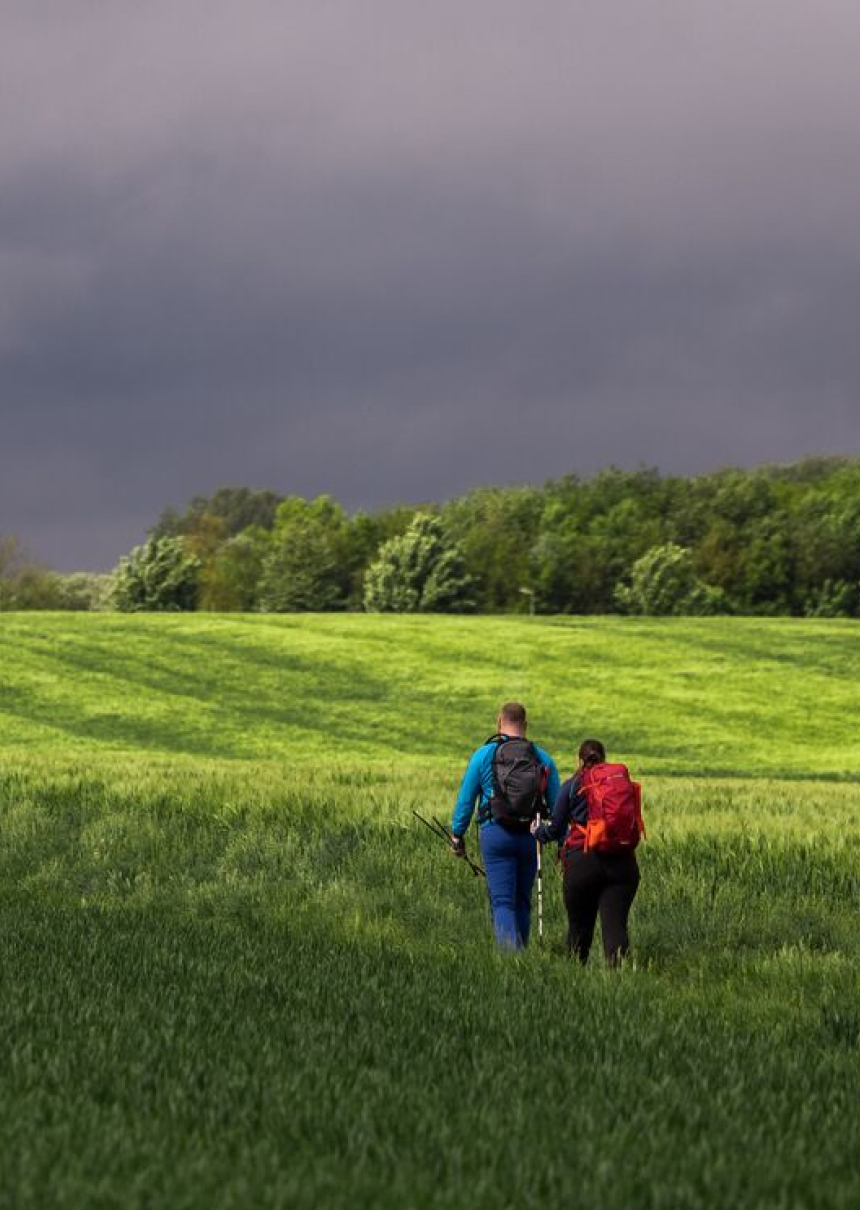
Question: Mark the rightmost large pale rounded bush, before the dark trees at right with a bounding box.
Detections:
[616,542,726,617]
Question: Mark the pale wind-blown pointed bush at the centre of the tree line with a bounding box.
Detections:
[364,513,474,613]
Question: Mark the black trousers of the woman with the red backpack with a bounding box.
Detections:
[564,851,639,967]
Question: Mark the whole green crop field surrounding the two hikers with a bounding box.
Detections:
[0,613,860,1210]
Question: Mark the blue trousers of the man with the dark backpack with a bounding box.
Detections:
[480,823,537,950]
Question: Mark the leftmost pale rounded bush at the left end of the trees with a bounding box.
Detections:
[111,537,201,613]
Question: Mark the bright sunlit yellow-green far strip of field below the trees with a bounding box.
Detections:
[0,613,860,778]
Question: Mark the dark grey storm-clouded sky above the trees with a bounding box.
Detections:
[0,0,860,569]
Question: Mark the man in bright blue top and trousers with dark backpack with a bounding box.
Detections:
[451,702,560,950]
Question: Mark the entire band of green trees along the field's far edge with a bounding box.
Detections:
[0,459,860,617]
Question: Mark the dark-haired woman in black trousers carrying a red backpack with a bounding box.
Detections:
[532,739,645,967]
